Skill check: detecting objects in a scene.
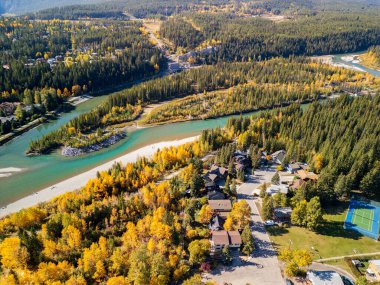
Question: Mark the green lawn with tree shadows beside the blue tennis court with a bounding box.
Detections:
[268,204,380,259]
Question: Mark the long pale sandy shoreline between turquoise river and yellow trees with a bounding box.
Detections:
[0,136,199,218]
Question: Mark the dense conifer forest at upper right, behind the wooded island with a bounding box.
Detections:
[160,12,380,60]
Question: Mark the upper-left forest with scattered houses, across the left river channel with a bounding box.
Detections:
[0,18,166,134]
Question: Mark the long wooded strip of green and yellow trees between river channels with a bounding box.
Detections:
[29,58,380,153]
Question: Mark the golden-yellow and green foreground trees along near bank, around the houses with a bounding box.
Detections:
[0,95,380,285]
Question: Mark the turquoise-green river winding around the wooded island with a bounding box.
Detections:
[0,51,380,207]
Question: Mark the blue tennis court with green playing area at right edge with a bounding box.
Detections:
[344,198,380,240]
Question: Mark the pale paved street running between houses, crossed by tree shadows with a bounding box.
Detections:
[204,168,285,285]
